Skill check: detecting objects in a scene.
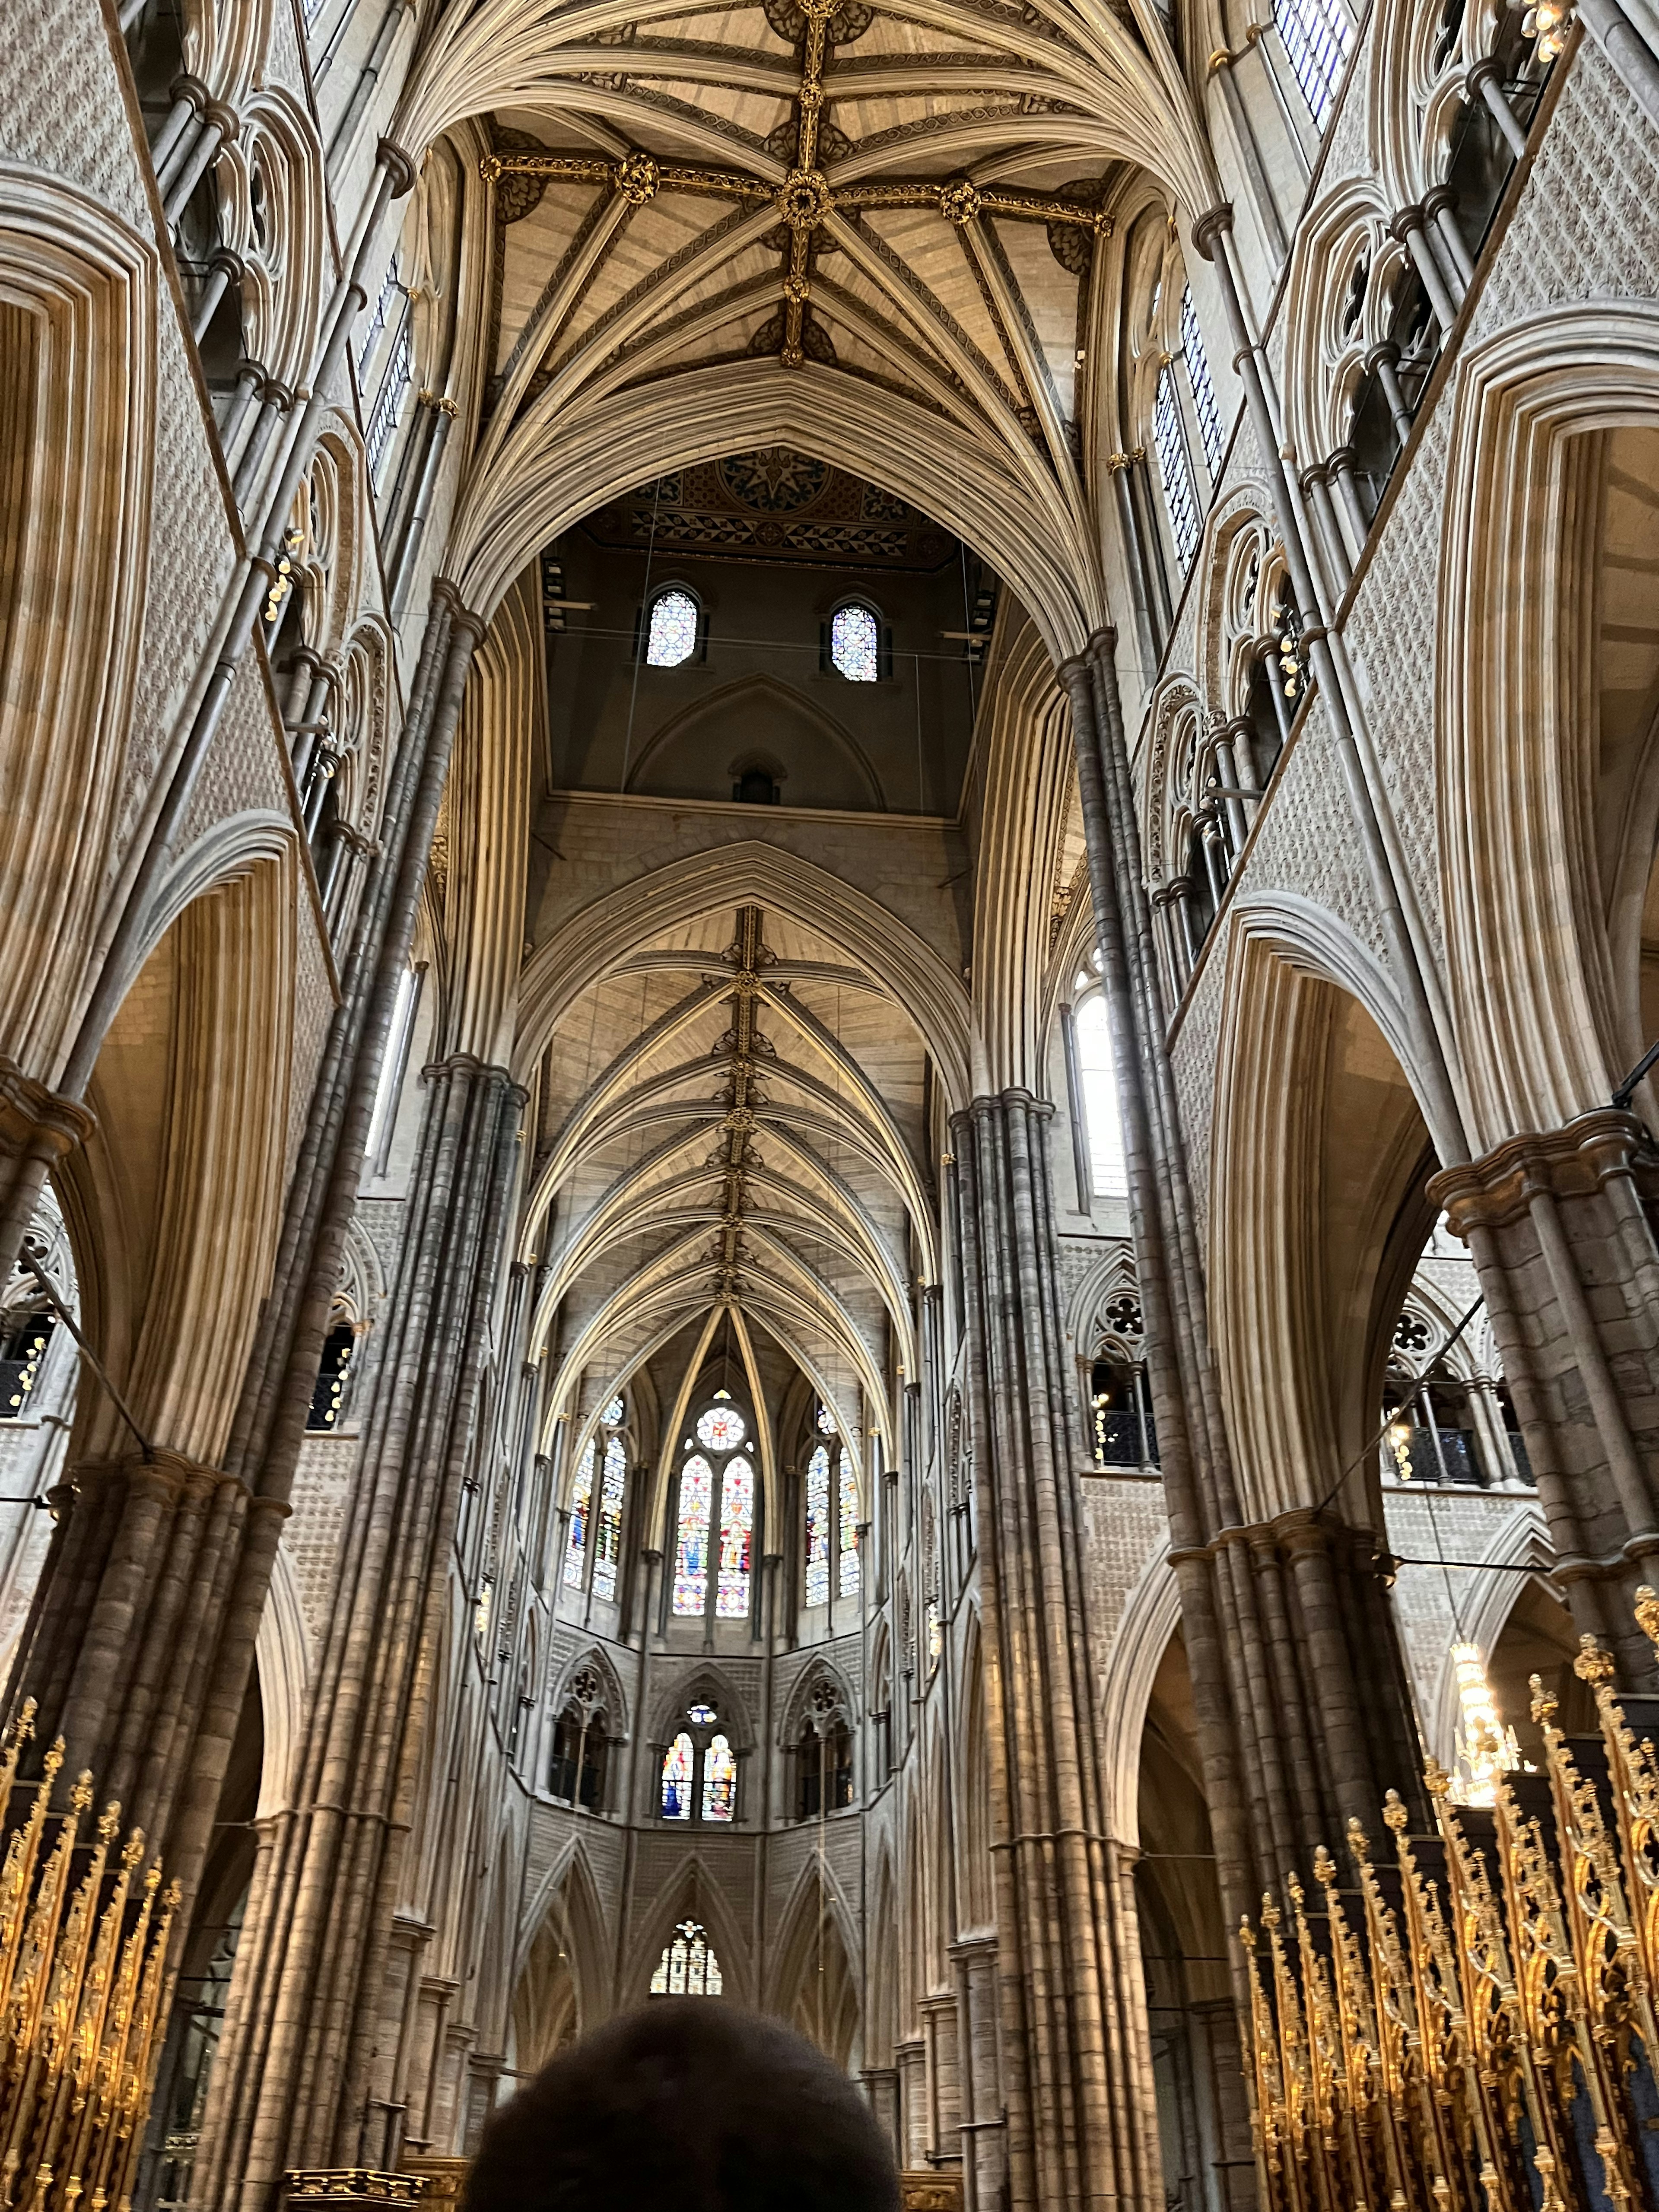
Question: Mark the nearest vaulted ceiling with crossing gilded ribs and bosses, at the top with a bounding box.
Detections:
[416,0,1217,637]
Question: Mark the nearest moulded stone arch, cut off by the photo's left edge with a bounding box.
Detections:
[0,164,166,1082]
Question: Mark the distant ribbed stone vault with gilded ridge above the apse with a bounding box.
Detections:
[524,903,938,1436]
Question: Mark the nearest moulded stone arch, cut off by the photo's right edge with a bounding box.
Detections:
[1436,301,1659,1153]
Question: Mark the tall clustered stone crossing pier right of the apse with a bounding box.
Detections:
[951,1090,1157,2206]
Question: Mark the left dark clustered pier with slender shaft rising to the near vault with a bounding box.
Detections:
[9,586,482,1896]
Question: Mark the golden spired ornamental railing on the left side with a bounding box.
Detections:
[0,1701,179,2212]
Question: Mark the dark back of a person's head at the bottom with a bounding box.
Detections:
[467,1997,898,2212]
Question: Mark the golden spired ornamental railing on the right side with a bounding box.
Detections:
[1241,1586,1659,2212]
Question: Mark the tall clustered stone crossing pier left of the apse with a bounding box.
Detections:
[197,1055,524,2208]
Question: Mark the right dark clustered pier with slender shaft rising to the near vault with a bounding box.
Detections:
[1059,630,1418,1975]
